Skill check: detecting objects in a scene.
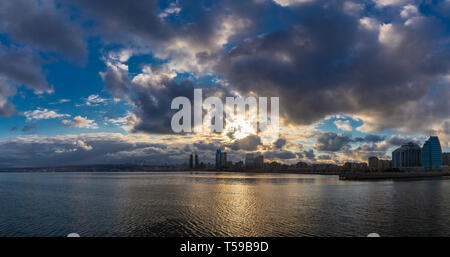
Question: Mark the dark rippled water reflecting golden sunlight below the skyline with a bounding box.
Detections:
[0,172,450,236]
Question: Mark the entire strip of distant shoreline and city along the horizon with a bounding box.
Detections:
[4,136,450,174]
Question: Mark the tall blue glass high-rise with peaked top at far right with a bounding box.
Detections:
[422,136,442,170]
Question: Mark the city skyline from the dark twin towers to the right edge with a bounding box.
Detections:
[181,136,450,172]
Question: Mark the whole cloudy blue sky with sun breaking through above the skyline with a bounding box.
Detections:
[0,0,450,167]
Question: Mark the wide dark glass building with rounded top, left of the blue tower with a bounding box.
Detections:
[392,142,422,168]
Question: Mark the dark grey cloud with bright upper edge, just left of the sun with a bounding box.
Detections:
[101,59,233,134]
